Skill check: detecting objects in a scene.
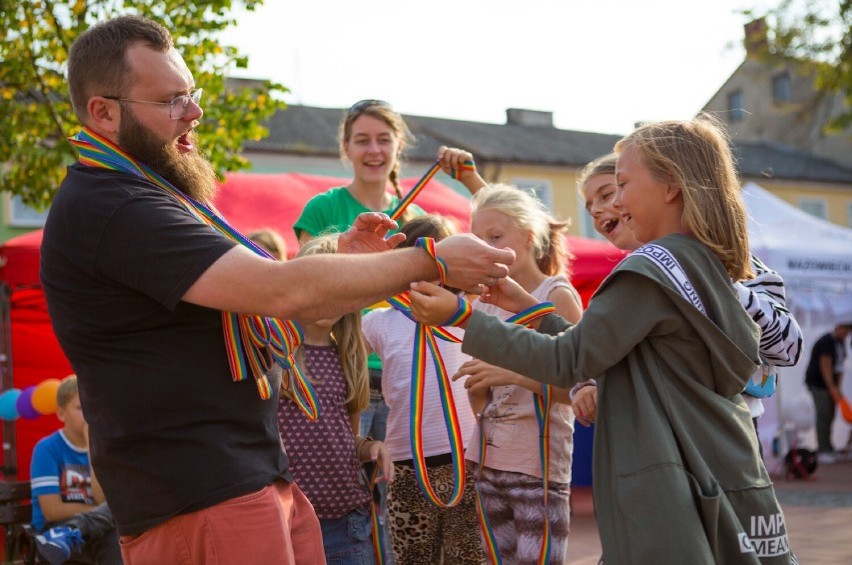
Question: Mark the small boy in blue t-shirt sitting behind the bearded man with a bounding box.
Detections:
[30,375,122,565]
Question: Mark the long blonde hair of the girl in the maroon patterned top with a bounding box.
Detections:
[281,234,370,414]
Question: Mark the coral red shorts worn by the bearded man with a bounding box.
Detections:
[116,481,325,565]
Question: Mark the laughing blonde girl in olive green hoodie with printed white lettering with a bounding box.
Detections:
[412,116,796,565]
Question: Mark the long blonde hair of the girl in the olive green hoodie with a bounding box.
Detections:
[615,114,754,280]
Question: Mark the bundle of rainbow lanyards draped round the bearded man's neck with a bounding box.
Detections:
[68,127,319,421]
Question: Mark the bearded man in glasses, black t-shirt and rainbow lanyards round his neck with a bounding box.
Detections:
[41,16,514,563]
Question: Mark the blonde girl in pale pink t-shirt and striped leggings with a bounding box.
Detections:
[457,185,597,563]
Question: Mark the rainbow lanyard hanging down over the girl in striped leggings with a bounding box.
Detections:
[476,302,556,565]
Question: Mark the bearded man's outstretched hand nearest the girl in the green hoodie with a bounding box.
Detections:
[435,233,515,294]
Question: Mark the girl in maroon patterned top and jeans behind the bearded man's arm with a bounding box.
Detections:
[278,236,393,563]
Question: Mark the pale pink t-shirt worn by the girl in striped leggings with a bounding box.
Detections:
[468,275,576,483]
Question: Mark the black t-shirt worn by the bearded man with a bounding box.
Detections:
[41,164,291,535]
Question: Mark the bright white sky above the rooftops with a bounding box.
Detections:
[216,0,775,134]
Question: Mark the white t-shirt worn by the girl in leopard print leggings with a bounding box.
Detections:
[361,308,476,461]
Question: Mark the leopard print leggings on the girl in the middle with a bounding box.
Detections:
[388,463,485,565]
